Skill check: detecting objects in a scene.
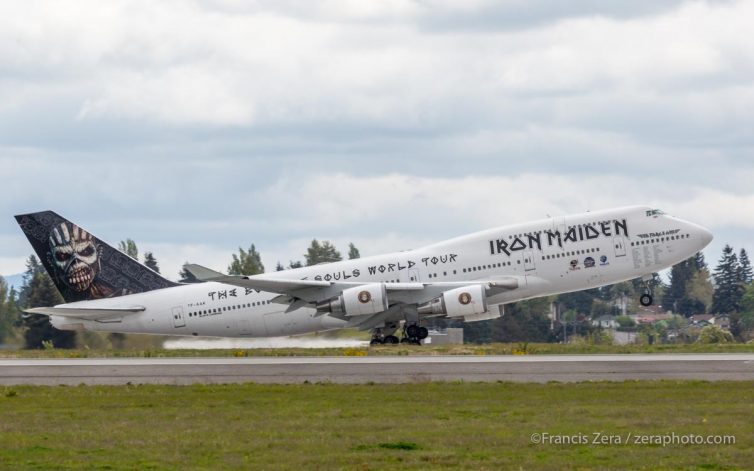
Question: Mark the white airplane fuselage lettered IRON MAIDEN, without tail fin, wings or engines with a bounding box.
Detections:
[51,206,712,337]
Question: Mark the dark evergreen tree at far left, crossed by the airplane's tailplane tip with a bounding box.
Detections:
[24,273,76,348]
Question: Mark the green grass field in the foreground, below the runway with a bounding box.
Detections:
[0,381,754,470]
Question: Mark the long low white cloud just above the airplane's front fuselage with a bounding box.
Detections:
[251,174,754,236]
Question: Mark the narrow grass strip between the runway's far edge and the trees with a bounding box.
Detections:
[0,343,754,358]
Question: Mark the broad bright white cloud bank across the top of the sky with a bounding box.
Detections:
[0,1,754,133]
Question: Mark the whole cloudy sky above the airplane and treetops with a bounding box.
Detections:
[0,0,754,279]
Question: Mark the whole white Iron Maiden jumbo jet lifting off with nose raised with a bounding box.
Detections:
[16,206,713,345]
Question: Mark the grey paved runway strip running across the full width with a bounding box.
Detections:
[0,353,754,385]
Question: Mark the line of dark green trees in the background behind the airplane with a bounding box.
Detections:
[0,239,754,348]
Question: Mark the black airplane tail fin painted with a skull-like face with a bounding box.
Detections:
[16,211,177,303]
